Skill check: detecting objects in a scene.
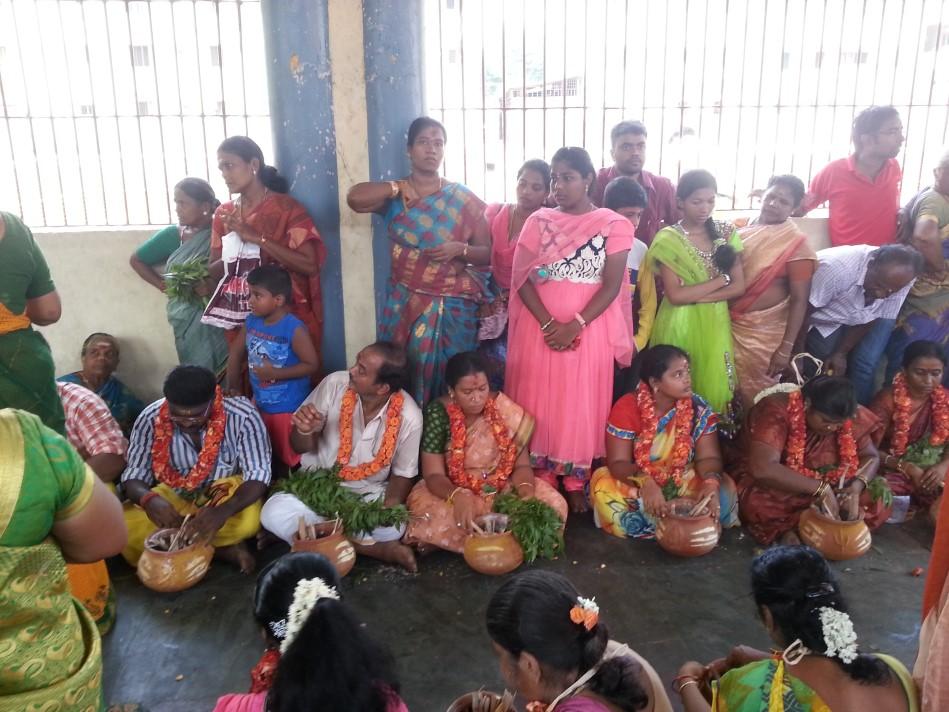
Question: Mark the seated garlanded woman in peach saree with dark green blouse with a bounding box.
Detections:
[405,351,567,553]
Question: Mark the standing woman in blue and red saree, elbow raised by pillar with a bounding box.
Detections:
[346,116,491,405]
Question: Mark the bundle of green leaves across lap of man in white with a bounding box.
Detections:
[273,467,409,534]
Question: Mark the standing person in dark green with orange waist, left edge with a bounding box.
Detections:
[0,212,66,434]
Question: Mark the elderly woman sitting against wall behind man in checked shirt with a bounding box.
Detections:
[56,332,145,436]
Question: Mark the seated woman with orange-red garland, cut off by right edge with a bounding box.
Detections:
[870,341,949,507]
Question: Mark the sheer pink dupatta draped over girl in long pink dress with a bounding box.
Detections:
[509,203,636,366]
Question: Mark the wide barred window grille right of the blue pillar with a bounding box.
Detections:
[424,0,949,209]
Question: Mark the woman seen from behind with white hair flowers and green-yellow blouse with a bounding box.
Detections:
[672,546,920,712]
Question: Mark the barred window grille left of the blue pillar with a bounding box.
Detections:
[0,0,273,227]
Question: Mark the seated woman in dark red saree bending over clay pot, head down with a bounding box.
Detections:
[733,376,888,544]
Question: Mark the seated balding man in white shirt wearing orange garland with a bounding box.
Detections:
[260,341,422,571]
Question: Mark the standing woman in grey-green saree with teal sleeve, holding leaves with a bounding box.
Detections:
[129,178,227,373]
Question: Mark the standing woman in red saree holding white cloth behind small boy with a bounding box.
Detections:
[202,136,326,362]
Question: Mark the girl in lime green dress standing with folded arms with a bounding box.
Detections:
[640,170,745,420]
